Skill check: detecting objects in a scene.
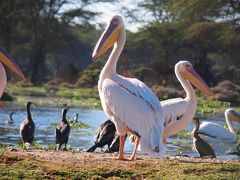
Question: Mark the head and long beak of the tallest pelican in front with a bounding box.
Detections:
[92,15,124,60]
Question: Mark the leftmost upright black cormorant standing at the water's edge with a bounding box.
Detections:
[19,102,35,144]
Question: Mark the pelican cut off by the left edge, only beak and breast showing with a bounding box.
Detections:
[0,48,25,97]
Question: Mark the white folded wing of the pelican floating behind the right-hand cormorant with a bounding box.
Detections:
[198,122,237,142]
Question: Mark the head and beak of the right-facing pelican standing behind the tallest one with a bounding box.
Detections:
[175,61,213,96]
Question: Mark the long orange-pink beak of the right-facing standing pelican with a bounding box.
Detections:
[181,66,214,96]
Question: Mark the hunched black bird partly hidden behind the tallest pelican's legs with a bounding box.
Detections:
[87,120,122,152]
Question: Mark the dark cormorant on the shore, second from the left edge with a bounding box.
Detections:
[56,108,71,151]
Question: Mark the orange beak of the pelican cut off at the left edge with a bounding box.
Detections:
[0,49,25,79]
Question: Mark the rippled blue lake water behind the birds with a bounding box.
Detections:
[0,106,240,158]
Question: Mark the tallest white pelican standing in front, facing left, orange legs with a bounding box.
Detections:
[93,15,166,160]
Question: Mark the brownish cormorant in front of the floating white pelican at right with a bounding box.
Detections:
[192,118,216,158]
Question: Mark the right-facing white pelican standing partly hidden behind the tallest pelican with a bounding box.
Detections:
[161,61,213,141]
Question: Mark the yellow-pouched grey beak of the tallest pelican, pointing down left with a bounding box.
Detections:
[92,22,120,61]
